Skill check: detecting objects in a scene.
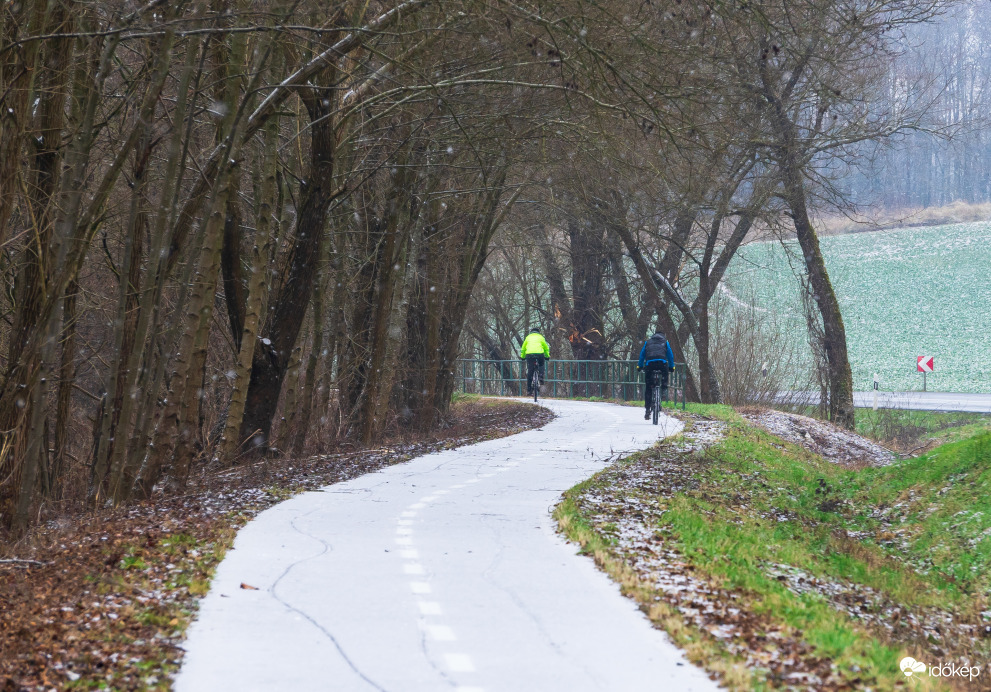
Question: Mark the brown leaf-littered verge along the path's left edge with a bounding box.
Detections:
[0,401,552,692]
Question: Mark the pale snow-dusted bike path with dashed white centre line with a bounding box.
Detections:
[176,401,716,692]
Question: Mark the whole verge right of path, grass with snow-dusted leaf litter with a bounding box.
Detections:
[556,406,991,690]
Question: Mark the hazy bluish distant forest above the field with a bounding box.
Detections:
[837,0,991,210]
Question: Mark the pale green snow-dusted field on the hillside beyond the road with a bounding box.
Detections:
[727,222,991,392]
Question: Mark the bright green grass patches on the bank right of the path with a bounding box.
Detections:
[559,407,991,689]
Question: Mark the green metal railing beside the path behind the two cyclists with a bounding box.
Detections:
[455,358,685,408]
